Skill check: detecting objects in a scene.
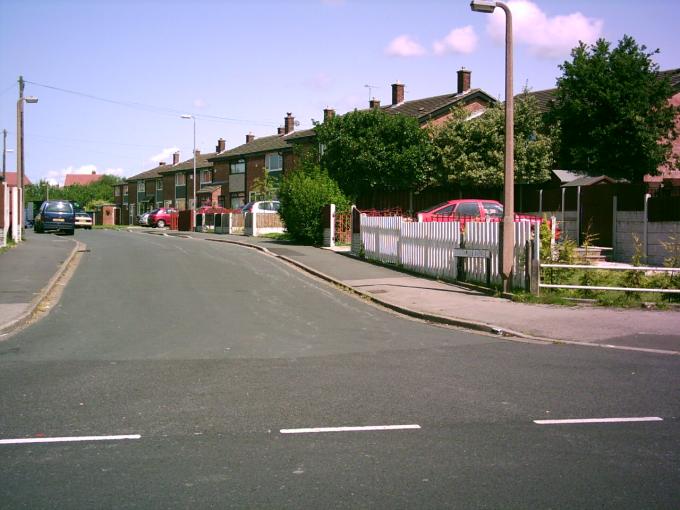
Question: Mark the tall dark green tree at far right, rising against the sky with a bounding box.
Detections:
[549,35,678,182]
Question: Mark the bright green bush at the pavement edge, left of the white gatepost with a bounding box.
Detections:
[279,165,349,245]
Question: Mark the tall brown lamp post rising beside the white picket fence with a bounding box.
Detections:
[470,0,515,292]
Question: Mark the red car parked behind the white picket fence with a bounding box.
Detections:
[418,198,542,223]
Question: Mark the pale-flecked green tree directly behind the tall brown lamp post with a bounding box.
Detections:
[431,91,554,187]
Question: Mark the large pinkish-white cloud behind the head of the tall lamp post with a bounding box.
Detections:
[487,0,603,58]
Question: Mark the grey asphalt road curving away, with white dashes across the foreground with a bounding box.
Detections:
[0,231,680,509]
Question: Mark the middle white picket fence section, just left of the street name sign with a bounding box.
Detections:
[399,222,460,278]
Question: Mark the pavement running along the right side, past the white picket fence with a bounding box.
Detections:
[161,231,680,354]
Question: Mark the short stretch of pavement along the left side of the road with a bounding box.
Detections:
[0,230,78,340]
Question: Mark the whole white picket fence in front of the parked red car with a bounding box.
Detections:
[354,215,538,287]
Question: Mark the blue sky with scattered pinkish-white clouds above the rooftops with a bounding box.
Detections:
[0,0,680,185]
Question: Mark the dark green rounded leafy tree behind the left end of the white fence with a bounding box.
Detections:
[316,109,432,198]
